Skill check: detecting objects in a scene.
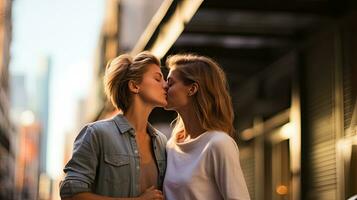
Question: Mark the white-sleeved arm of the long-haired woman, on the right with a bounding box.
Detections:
[212,136,250,200]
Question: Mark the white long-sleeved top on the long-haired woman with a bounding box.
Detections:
[164,131,250,200]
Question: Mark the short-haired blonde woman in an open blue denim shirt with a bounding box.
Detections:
[60,52,167,200]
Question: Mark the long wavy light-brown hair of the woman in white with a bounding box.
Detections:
[166,54,234,137]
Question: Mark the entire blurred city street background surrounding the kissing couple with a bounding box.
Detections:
[0,0,357,200]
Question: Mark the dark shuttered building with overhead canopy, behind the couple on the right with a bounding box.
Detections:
[133,0,357,200]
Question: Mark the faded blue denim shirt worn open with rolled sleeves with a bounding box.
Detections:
[60,114,167,198]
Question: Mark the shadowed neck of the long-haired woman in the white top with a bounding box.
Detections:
[178,108,206,138]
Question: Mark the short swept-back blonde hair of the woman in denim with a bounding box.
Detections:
[104,51,160,112]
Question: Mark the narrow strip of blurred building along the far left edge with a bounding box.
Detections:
[0,0,15,199]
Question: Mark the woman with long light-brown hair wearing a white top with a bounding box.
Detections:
[164,54,250,200]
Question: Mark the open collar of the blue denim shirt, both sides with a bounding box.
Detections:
[114,114,158,137]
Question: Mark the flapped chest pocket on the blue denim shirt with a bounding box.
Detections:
[103,154,131,185]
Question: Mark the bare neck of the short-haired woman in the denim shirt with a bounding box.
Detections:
[124,97,153,134]
